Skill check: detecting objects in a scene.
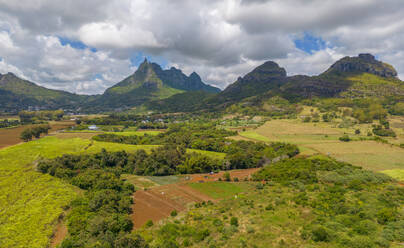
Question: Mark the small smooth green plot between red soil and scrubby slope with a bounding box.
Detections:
[188,182,248,199]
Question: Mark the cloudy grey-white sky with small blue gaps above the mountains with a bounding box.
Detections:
[0,0,404,94]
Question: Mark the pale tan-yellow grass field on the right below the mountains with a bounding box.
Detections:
[239,117,404,180]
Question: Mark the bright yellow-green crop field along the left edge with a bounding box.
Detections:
[0,136,225,247]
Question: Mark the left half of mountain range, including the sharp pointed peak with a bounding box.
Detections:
[0,60,220,113]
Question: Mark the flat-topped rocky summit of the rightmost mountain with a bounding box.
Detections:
[323,53,397,78]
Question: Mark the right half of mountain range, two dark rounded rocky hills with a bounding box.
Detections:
[150,54,404,112]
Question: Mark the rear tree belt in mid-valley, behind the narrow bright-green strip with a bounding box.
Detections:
[93,124,299,170]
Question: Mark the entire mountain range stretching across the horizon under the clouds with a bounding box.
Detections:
[0,54,404,112]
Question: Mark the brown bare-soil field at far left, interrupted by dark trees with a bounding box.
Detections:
[0,121,74,149]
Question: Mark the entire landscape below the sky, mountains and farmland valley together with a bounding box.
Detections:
[0,54,404,248]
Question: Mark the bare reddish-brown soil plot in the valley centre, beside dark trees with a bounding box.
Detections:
[132,168,259,229]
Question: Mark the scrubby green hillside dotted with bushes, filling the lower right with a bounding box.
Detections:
[136,157,404,248]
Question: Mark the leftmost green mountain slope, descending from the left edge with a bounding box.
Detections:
[0,73,88,113]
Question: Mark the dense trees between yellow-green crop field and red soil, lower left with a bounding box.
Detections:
[38,150,145,247]
